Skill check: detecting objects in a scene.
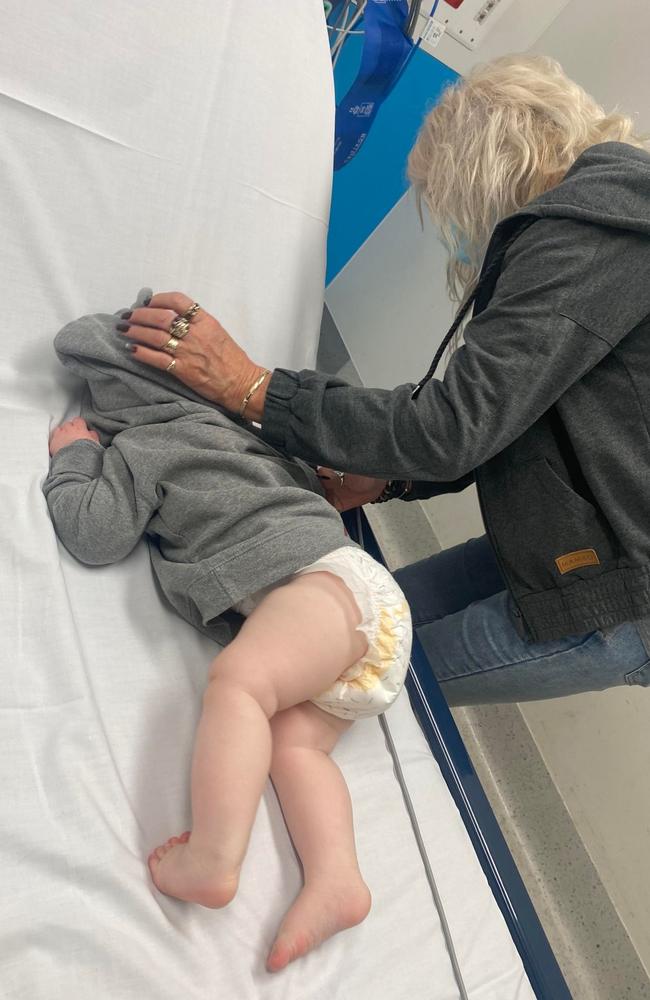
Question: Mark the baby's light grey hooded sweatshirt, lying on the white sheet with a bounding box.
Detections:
[43,289,354,644]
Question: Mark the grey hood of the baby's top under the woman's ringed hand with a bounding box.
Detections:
[54,288,236,444]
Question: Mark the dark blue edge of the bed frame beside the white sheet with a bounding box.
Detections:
[344,510,572,1000]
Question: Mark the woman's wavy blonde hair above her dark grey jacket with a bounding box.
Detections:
[408,55,646,302]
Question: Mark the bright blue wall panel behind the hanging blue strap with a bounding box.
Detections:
[327,42,458,284]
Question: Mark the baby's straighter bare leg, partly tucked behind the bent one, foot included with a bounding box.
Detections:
[267,702,370,972]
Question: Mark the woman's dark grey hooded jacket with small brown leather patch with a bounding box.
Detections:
[262,142,650,645]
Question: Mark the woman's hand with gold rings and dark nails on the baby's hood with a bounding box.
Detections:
[118,292,268,420]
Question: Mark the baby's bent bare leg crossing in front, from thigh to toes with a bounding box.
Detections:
[149,573,367,907]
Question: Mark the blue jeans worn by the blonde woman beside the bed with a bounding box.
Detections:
[395,535,650,705]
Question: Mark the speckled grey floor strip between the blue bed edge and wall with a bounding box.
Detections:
[317,309,650,1000]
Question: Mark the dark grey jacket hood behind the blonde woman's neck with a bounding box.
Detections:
[510,142,650,236]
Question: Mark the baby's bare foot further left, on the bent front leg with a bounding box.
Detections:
[148,830,239,909]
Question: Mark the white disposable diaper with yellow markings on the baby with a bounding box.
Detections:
[234,546,412,719]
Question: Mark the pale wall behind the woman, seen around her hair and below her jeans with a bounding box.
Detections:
[326,0,650,971]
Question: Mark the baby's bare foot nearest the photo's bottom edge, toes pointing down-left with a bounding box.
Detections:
[266,873,371,972]
